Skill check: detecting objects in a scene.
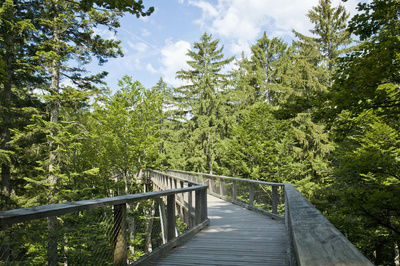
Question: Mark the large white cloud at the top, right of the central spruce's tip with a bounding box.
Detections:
[189,0,358,54]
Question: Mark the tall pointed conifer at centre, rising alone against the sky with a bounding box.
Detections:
[175,33,233,173]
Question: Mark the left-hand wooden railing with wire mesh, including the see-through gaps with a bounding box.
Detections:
[0,171,209,265]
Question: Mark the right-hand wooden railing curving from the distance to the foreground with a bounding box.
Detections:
[166,170,373,266]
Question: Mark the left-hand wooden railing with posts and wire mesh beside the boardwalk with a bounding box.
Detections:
[0,171,209,265]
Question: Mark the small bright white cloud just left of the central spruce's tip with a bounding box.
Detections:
[160,40,190,86]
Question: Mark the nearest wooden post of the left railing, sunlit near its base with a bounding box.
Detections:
[113,203,127,266]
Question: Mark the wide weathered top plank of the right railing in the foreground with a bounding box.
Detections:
[285,185,373,266]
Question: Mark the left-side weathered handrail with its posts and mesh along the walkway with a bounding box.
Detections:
[0,170,209,265]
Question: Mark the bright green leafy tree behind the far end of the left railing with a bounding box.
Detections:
[89,76,162,188]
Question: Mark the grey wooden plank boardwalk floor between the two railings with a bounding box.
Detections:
[151,195,288,266]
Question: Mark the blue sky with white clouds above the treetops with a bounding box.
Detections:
[88,0,359,91]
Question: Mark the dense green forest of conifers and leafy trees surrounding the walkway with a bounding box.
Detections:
[0,0,400,265]
